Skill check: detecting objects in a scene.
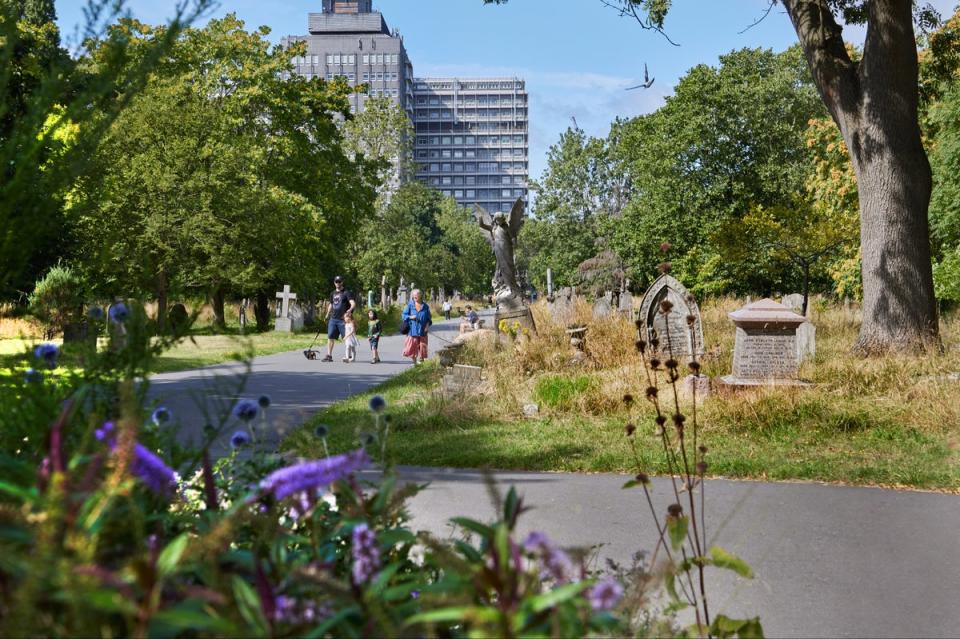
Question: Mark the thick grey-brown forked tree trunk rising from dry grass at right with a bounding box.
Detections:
[784,0,938,354]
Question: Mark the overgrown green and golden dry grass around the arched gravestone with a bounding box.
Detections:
[288,300,960,491]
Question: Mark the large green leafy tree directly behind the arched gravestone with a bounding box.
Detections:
[604,48,825,293]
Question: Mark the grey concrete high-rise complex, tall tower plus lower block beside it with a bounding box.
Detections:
[282,0,530,212]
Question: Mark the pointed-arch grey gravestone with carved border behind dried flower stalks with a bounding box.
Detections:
[638,273,703,358]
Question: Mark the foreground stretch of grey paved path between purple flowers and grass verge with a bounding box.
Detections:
[402,468,960,637]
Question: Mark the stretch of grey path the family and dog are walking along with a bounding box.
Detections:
[150,316,459,457]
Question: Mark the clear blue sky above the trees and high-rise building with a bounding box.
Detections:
[57,0,958,177]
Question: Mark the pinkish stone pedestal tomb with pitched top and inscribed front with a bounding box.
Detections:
[722,299,808,386]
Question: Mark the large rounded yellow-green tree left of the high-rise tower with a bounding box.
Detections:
[72,15,373,326]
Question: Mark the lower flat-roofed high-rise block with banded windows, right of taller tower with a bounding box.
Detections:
[413,78,530,211]
